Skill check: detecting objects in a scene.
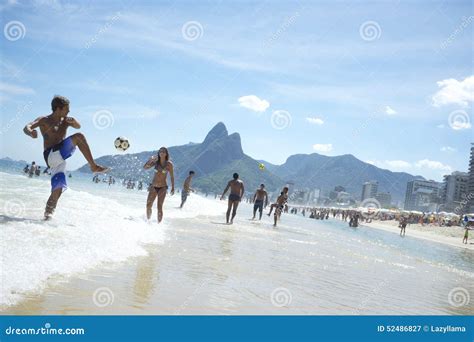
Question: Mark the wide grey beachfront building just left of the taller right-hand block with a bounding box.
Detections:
[404,180,443,212]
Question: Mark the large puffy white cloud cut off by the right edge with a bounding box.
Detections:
[432,75,474,107]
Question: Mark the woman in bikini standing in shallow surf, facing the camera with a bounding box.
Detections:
[143,147,174,223]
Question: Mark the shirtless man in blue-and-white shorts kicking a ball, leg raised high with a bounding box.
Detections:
[23,95,108,220]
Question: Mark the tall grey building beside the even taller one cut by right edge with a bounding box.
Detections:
[440,171,469,212]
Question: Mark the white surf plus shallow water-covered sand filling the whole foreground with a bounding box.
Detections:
[0,173,474,314]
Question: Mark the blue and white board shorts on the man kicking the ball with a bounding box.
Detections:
[43,137,76,192]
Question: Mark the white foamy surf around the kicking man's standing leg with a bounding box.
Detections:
[0,172,224,306]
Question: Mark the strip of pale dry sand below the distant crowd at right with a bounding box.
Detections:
[360,221,474,250]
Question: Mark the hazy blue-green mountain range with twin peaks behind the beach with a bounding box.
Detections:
[78,122,423,202]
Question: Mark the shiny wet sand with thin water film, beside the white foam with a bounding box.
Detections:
[2,212,474,315]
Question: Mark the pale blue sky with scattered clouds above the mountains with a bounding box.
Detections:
[0,0,474,181]
